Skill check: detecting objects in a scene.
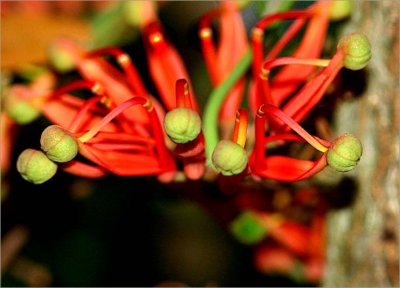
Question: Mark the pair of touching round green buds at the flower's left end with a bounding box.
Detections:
[17,125,79,184]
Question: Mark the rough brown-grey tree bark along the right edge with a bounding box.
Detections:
[324,0,400,287]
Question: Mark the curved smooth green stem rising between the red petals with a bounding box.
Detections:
[203,50,252,163]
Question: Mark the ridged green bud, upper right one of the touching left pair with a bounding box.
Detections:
[40,125,79,163]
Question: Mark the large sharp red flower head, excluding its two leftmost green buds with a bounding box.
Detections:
[14,1,370,189]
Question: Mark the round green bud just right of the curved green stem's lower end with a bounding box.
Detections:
[212,140,248,176]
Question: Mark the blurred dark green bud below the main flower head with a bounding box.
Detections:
[230,211,267,245]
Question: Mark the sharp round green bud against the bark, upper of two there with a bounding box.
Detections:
[337,33,371,70]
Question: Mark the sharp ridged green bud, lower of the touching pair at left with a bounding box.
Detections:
[17,149,57,184]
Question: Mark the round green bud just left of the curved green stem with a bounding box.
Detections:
[164,108,201,144]
